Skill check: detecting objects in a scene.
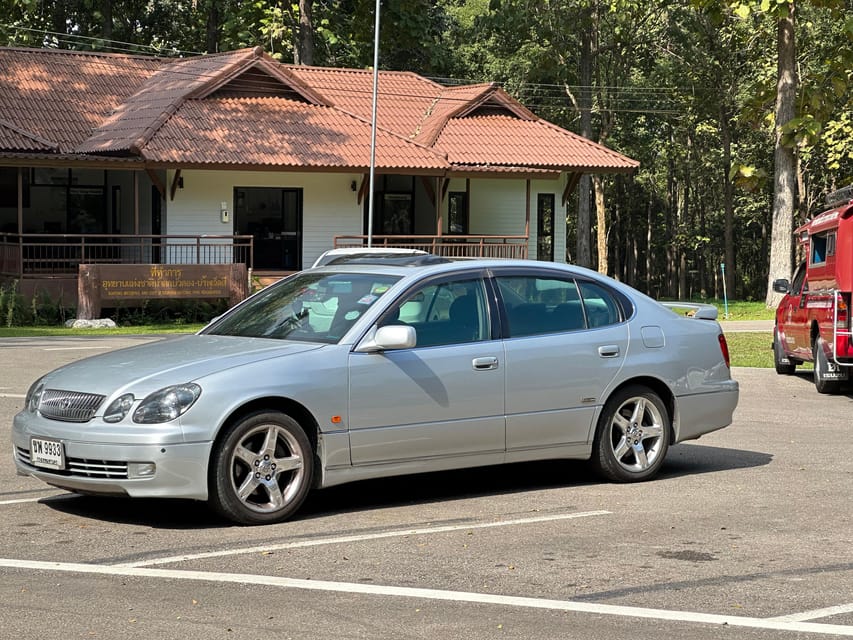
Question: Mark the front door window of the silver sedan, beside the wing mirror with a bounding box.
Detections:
[380,278,491,348]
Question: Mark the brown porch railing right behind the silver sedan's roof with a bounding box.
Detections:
[335,235,528,259]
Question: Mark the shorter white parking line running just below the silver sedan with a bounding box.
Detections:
[120,511,611,567]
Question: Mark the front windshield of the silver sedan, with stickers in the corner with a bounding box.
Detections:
[202,272,400,344]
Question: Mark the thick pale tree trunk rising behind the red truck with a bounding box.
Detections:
[766,3,797,307]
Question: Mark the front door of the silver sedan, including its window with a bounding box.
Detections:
[349,276,505,470]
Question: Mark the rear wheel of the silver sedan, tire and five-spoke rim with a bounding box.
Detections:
[592,385,672,482]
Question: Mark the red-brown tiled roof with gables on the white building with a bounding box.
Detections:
[0,48,637,174]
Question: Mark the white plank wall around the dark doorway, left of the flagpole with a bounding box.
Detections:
[164,171,363,268]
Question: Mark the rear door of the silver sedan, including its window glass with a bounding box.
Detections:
[495,271,628,460]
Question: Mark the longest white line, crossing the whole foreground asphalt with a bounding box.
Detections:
[0,558,853,637]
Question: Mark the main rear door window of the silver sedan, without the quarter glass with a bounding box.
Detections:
[497,276,587,338]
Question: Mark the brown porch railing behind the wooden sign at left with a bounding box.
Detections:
[0,233,254,278]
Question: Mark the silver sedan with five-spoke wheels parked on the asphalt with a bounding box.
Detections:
[12,260,738,524]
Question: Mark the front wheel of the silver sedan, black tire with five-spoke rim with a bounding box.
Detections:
[209,412,314,524]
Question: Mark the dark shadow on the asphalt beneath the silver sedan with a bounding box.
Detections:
[41,443,773,530]
